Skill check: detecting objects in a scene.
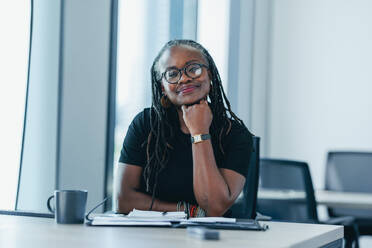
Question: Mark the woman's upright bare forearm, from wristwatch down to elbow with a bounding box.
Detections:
[192,140,233,216]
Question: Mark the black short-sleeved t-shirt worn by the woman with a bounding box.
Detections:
[119,108,252,204]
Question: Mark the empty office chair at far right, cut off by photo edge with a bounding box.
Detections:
[325,151,372,235]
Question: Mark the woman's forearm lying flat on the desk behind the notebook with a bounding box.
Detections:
[118,189,177,213]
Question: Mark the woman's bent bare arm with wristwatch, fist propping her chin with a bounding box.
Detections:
[182,101,245,216]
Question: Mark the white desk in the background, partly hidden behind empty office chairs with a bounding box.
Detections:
[257,189,372,210]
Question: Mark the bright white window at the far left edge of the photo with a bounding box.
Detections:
[0,0,31,209]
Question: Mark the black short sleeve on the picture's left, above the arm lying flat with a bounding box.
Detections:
[119,109,150,167]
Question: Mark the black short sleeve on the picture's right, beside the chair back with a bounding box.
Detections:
[221,121,253,177]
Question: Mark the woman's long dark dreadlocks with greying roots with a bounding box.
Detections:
[143,40,244,210]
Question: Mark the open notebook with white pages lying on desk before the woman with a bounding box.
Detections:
[88,209,267,230]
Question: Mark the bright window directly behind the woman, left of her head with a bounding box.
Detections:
[114,0,197,205]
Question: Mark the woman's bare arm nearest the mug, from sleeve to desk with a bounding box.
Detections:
[117,163,177,213]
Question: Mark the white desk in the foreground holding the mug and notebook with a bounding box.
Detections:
[0,215,343,248]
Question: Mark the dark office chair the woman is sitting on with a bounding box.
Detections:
[230,136,260,219]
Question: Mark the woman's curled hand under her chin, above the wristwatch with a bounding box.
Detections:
[182,100,213,135]
